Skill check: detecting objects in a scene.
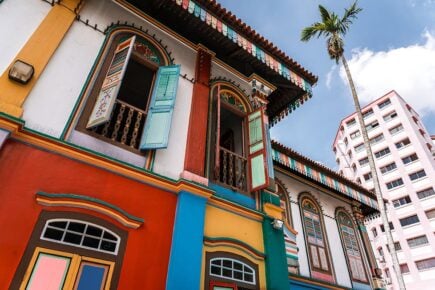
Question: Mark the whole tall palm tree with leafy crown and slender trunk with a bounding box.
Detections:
[301,2,405,289]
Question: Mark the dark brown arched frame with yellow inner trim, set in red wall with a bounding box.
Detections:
[10,211,127,289]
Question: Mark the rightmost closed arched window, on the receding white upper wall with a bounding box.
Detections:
[336,210,368,283]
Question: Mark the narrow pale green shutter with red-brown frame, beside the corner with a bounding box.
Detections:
[247,108,269,191]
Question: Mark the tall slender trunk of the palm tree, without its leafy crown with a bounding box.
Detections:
[341,55,406,289]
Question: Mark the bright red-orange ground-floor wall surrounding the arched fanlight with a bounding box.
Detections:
[0,140,177,289]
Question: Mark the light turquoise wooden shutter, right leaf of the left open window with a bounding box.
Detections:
[139,65,180,150]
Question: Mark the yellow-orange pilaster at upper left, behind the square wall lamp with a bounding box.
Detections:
[0,0,80,118]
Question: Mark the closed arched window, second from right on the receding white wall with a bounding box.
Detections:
[300,196,334,282]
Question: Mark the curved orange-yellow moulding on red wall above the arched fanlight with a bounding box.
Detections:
[36,197,142,229]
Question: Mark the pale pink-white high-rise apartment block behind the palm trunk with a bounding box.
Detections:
[333,91,435,290]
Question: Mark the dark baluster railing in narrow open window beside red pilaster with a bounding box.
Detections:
[217,147,247,192]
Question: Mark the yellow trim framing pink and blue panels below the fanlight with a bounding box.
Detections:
[20,247,115,290]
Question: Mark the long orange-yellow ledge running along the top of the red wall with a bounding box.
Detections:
[0,117,213,199]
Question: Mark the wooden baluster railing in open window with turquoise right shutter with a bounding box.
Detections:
[90,100,146,150]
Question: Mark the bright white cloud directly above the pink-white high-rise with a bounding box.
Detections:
[340,32,435,116]
